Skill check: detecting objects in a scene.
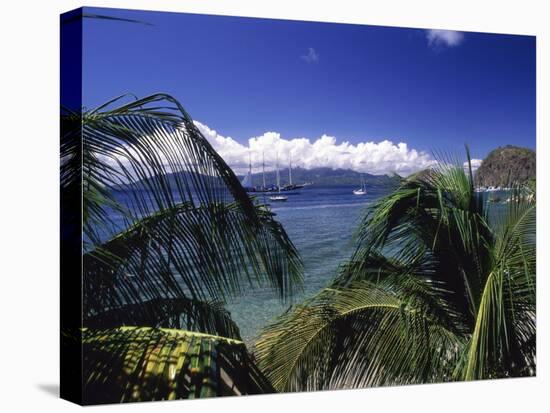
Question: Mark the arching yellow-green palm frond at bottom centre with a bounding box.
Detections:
[256,275,463,391]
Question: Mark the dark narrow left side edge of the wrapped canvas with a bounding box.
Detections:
[60,9,82,404]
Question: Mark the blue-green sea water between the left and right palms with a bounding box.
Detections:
[226,185,389,343]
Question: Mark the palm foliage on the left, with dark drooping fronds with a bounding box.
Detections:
[61,94,302,403]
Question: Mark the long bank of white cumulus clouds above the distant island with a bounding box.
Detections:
[195,121,435,176]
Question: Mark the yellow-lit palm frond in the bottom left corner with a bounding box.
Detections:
[82,327,273,404]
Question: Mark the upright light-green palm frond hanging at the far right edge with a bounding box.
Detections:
[464,191,536,380]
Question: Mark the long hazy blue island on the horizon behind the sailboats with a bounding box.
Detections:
[238,167,402,186]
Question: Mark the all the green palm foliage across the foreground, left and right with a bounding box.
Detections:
[61,94,536,403]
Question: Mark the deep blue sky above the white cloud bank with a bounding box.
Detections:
[83,9,535,171]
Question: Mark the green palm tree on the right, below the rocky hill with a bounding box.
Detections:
[256,154,536,391]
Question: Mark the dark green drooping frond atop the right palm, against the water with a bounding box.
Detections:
[348,182,491,324]
